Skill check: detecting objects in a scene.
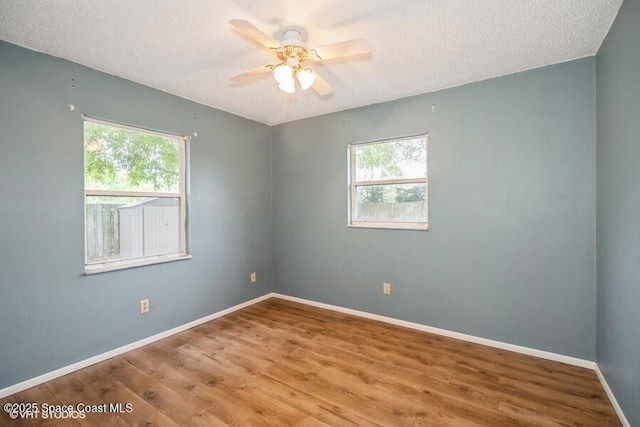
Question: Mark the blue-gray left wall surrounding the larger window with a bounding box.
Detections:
[0,42,273,389]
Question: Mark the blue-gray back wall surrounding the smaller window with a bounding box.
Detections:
[273,58,596,360]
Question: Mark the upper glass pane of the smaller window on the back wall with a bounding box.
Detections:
[355,137,427,181]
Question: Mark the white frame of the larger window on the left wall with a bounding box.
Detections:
[82,115,192,275]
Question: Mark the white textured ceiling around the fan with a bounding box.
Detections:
[0,0,622,125]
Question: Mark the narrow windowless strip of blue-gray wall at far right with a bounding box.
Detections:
[596,0,640,426]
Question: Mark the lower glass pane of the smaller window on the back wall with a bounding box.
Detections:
[354,184,427,222]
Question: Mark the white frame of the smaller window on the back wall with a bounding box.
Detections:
[347,132,429,231]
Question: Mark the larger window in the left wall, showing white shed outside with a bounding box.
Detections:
[84,117,189,274]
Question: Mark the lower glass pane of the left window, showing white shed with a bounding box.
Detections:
[86,196,181,264]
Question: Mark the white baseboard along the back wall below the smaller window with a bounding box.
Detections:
[272,293,596,369]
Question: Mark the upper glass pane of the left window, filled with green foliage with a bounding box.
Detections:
[84,122,180,193]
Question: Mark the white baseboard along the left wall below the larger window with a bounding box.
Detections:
[0,293,273,399]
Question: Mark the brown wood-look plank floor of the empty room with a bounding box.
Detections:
[0,299,620,426]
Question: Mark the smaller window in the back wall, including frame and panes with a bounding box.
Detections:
[349,135,428,230]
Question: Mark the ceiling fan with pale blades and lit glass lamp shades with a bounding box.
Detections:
[229,19,371,96]
